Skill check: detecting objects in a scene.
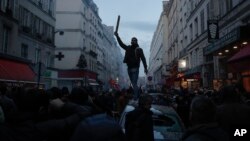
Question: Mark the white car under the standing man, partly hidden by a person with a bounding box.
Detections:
[119,104,185,141]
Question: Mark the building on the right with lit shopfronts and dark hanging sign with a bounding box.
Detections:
[151,0,250,90]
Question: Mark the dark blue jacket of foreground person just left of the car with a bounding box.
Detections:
[71,114,125,141]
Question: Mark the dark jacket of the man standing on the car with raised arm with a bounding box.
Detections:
[117,36,147,69]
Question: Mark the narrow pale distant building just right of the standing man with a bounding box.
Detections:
[147,1,169,89]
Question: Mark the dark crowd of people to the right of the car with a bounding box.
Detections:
[163,84,250,141]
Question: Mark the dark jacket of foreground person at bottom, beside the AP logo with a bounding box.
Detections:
[182,123,229,141]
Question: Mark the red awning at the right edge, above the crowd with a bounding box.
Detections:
[228,45,250,62]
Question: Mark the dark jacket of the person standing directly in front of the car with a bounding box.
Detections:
[125,108,154,141]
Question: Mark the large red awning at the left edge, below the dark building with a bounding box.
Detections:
[0,59,35,81]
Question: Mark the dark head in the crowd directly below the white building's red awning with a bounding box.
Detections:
[69,87,89,105]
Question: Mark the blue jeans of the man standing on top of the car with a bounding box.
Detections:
[128,68,139,99]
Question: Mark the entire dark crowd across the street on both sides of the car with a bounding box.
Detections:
[0,83,250,141]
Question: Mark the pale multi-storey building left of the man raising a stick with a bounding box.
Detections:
[55,0,125,90]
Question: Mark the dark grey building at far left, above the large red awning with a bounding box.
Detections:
[0,0,56,88]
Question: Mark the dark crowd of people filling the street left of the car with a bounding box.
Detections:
[0,84,129,141]
